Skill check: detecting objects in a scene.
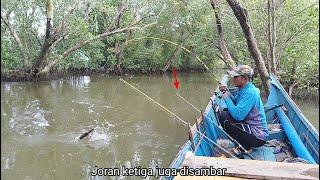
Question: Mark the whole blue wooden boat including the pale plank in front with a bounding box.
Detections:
[167,75,319,179]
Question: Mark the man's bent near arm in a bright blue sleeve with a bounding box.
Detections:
[224,92,256,121]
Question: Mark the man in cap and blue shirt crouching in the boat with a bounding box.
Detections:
[219,65,269,157]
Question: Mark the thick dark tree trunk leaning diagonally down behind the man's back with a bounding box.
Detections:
[227,0,270,96]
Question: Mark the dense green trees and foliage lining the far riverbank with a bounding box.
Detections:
[1,0,319,93]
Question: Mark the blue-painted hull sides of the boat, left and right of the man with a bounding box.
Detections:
[169,75,319,179]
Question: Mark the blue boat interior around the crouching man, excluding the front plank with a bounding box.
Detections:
[189,74,319,164]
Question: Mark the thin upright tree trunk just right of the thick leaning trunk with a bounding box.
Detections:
[267,0,277,76]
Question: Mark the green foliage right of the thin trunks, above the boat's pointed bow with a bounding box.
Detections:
[277,1,319,89]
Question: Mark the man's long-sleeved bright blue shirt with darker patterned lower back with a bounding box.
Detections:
[225,82,269,140]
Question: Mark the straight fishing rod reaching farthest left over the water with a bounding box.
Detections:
[119,78,237,158]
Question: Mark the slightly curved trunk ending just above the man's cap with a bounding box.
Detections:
[210,0,235,70]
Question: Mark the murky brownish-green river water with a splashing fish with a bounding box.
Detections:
[1,74,319,179]
